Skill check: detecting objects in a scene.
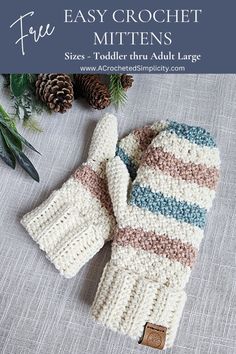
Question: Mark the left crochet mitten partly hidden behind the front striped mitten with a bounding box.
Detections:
[21,114,165,278]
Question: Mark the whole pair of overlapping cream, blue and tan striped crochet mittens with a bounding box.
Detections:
[22,115,219,349]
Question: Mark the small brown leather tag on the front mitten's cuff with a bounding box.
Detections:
[140,322,167,349]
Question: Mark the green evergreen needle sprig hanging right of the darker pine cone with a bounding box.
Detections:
[109,74,127,108]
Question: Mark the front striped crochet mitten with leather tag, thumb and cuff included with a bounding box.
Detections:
[92,122,220,349]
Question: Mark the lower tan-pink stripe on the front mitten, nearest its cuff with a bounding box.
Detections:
[114,227,197,267]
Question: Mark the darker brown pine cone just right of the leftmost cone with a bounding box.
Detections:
[75,74,111,109]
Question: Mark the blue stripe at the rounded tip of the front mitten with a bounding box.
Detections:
[167,122,216,147]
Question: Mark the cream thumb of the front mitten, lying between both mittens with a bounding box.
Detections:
[106,156,131,223]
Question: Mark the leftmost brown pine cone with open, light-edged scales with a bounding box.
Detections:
[36,74,74,113]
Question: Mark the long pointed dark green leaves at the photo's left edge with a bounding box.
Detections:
[0,105,39,182]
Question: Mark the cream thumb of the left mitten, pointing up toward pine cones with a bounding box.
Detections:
[88,114,118,163]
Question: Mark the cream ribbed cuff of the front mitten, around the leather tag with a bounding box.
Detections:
[92,262,186,348]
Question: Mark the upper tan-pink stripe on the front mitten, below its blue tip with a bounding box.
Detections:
[143,147,219,189]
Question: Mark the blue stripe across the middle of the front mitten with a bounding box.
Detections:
[130,183,207,228]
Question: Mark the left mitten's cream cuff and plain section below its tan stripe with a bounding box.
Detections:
[21,178,114,278]
